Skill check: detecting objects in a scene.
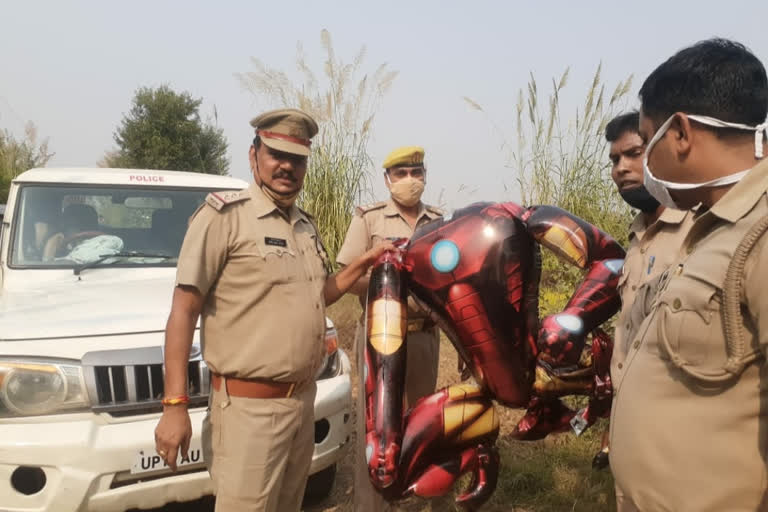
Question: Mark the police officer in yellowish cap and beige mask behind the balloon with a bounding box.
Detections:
[336,146,442,512]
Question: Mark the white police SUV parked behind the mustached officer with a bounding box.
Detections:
[0,168,351,512]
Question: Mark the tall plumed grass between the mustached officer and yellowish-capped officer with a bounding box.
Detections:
[235,30,397,266]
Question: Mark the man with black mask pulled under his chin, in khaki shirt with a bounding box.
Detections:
[594,111,693,467]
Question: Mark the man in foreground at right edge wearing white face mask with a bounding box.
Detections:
[610,39,768,512]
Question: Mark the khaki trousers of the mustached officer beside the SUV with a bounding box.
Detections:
[202,381,317,512]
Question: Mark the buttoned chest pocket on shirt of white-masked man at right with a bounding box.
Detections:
[656,275,725,366]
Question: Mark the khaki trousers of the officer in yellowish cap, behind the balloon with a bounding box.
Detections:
[354,322,440,512]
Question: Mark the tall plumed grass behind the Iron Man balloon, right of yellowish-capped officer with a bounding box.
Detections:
[465,65,632,314]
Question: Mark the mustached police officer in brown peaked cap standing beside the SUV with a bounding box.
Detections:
[155,109,391,512]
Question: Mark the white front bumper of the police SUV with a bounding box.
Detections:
[0,353,352,512]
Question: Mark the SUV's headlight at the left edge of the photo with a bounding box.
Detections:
[0,361,89,417]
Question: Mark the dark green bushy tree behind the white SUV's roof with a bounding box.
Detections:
[106,85,229,174]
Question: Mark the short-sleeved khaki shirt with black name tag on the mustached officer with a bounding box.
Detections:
[176,185,327,382]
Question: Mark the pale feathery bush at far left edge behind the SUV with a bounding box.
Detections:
[0,122,54,204]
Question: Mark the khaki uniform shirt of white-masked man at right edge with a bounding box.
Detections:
[611,159,768,512]
